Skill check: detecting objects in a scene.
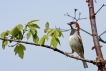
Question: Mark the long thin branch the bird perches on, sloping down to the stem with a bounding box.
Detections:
[0,38,96,64]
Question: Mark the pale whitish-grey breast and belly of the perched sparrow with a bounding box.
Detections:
[69,34,82,53]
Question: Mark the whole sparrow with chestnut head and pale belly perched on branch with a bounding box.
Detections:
[66,21,88,68]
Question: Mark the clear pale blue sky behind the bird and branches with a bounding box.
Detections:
[0,0,106,71]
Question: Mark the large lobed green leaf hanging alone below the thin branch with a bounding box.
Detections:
[14,44,26,59]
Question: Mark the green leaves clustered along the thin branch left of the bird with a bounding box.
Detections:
[0,20,63,59]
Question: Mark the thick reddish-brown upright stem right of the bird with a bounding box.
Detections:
[88,0,106,71]
